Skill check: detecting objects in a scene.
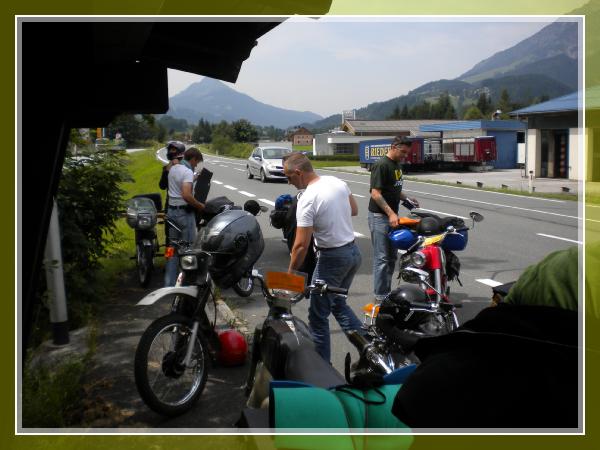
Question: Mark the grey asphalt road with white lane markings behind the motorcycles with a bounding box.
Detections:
[204,155,580,371]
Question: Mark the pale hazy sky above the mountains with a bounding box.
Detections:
[169,17,568,117]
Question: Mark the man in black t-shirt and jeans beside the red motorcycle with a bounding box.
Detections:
[368,136,419,302]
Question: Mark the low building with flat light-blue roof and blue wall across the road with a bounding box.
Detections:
[419,120,527,169]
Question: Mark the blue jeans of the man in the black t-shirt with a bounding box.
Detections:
[368,211,398,301]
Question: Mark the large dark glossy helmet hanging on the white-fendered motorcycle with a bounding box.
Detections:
[195,209,265,289]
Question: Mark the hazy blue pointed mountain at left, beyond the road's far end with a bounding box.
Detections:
[167,78,323,129]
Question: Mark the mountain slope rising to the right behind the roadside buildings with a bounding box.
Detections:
[303,19,580,130]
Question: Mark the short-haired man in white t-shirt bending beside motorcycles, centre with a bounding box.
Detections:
[283,153,362,362]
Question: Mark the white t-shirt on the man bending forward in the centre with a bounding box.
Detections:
[296,176,354,248]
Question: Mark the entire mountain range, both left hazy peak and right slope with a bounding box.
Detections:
[167,14,580,131]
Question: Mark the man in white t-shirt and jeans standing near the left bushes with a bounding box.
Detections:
[165,147,204,286]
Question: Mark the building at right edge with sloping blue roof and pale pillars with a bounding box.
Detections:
[509,92,583,179]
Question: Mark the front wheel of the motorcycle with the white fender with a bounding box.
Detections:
[134,314,210,416]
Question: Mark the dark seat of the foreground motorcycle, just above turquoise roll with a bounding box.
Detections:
[285,347,346,388]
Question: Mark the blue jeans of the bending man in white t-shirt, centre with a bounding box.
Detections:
[308,243,362,362]
